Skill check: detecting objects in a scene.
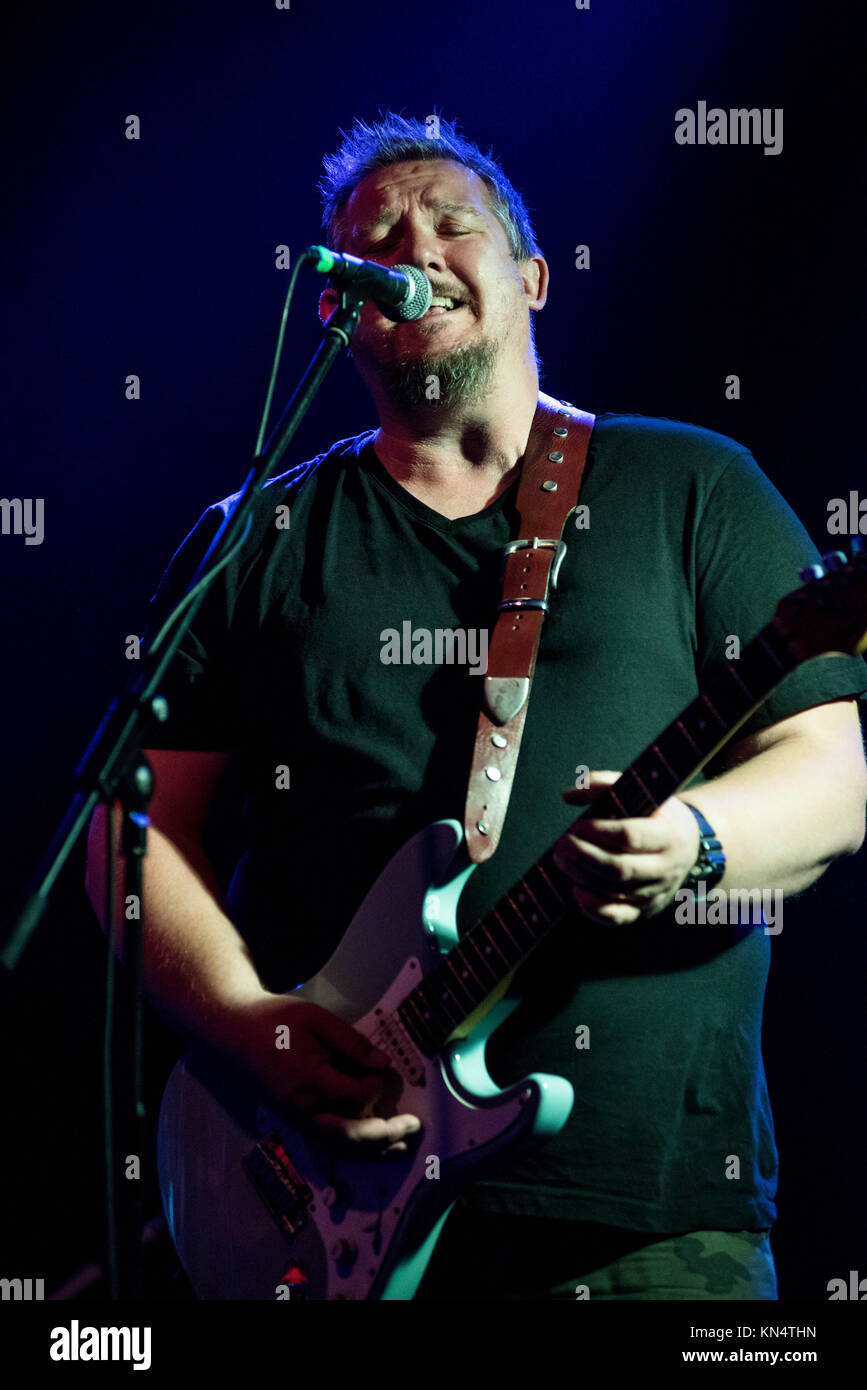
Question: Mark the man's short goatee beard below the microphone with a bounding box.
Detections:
[355,339,500,410]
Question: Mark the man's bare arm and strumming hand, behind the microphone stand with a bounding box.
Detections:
[86,749,420,1147]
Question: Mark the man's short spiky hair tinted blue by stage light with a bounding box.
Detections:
[318,111,540,261]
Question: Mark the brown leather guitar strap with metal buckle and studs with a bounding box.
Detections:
[464,392,596,863]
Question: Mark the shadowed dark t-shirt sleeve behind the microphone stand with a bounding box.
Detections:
[145,503,240,752]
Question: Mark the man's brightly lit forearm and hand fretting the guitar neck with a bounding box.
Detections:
[556,701,867,923]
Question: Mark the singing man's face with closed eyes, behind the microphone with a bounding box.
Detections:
[321,160,547,407]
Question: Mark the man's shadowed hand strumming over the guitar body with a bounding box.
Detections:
[232,994,421,1154]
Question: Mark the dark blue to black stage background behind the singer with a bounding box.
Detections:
[0,0,867,1300]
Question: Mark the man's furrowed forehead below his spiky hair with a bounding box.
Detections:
[343,160,499,235]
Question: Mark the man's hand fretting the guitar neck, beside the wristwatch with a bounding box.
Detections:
[554,771,700,926]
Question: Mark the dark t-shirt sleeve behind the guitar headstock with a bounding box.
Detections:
[695,450,867,738]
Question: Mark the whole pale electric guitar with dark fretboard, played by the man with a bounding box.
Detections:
[158,539,867,1300]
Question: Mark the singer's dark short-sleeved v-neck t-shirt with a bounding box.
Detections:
[147,413,867,1232]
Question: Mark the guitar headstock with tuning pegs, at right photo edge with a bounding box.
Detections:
[774,537,867,662]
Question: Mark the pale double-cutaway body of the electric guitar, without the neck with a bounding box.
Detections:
[158,820,574,1300]
